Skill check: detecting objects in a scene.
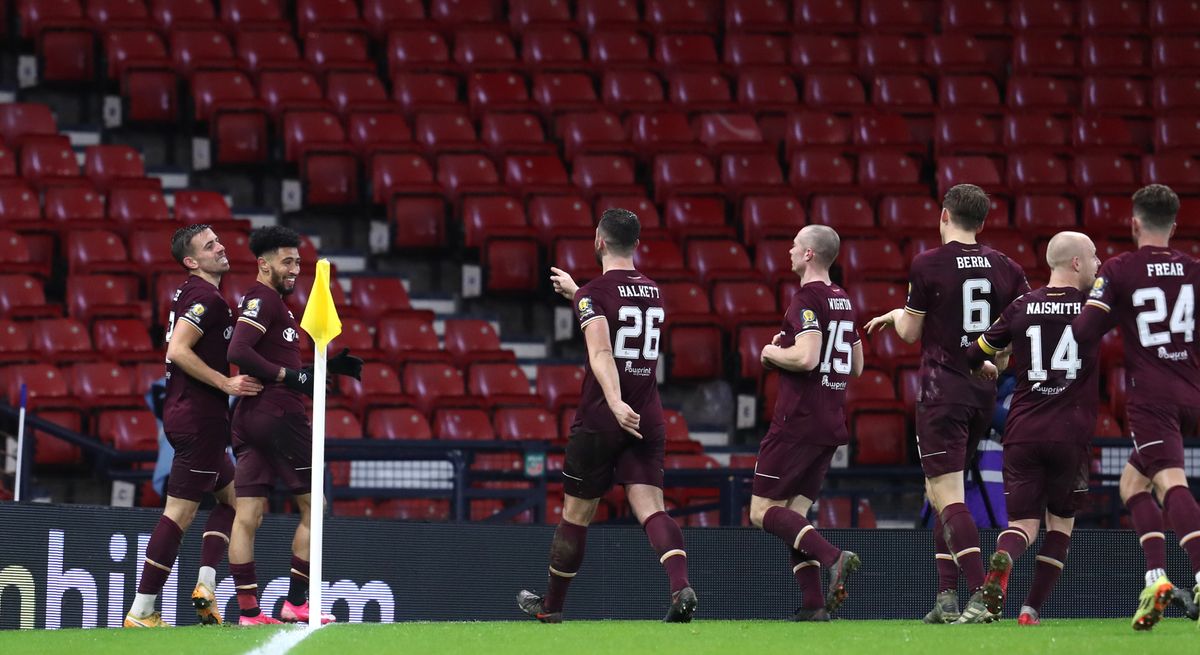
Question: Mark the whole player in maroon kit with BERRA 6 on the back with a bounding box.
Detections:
[866,185,1030,623]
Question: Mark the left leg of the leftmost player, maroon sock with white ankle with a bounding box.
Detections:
[125,495,200,627]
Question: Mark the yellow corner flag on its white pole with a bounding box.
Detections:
[300,259,342,629]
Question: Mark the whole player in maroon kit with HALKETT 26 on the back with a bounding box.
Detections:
[517,209,697,623]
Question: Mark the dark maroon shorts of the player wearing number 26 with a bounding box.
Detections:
[563,427,667,500]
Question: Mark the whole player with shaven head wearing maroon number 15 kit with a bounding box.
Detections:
[750,226,863,621]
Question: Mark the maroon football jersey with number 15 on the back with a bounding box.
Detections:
[767,282,859,446]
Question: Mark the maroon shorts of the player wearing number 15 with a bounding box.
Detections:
[754,438,838,500]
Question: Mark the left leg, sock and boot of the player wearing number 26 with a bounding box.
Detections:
[517,494,600,623]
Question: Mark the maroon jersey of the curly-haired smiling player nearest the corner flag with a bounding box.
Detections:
[230,282,306,411]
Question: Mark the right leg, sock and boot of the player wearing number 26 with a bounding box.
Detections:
[625,485,697,623]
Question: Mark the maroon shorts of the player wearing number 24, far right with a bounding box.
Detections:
[1126,403,1200,479]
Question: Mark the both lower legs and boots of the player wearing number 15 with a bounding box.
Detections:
[750,495,860,614]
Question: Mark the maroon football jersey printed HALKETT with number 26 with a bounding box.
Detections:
[572,270,666,437]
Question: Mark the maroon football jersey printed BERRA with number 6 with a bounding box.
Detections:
[905,241,1030,408]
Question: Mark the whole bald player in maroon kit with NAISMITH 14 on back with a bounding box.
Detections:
[967,232,1100,625]
